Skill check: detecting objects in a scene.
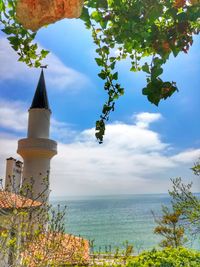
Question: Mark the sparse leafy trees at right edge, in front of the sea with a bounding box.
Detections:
[152,161,200,248]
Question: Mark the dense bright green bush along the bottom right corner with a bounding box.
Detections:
[127,247,200,267]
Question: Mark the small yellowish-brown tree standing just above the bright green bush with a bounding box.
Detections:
[154,206,187,248]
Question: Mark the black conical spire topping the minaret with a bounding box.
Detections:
[30,69,49,109]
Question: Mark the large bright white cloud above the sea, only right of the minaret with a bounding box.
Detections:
[49,113,200,195]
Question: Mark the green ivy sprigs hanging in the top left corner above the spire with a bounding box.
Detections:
[0,0,49,68]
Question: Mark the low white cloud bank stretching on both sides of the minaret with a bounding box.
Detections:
[0,100,200,195]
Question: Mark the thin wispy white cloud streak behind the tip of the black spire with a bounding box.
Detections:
[0,38,90,91]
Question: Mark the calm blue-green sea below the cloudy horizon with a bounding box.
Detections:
[51,194,200,253]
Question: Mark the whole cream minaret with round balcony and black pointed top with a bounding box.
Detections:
[17,69,57,202]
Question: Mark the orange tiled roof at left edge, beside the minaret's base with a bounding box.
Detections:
[0,190,42,209]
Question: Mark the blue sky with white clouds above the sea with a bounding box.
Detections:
[0,20,200,196]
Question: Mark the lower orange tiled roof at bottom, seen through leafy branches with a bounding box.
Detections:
[22,232,89,267]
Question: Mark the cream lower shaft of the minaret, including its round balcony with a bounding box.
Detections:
[17,138,57,202]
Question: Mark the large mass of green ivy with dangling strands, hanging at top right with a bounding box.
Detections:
[81,0,200,143]
